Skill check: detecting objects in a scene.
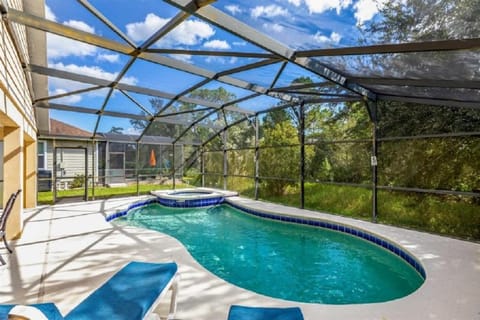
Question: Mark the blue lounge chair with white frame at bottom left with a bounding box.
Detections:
[0,261,178,320]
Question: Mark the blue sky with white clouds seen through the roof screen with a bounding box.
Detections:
[45,0,385,134]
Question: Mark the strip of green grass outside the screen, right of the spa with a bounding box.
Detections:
[251,183,480,241]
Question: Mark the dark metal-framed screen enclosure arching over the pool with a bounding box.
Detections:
[2,0,480,240]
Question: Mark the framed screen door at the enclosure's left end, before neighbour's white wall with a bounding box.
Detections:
[53,147,88,203]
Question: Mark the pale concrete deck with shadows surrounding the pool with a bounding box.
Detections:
[0,196,480,320]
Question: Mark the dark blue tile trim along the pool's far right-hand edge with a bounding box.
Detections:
[225,200,426,279]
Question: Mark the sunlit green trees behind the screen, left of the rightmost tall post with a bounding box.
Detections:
[260,73,372,193]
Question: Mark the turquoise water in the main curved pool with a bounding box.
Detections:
[120,204,424,304]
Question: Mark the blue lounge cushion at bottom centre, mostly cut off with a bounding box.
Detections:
[228,306,303,320]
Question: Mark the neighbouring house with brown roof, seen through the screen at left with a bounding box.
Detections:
[37,119,193,191]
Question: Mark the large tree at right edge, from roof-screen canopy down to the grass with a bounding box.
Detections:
[344,0,480,195]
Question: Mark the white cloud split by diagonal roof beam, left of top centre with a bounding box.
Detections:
[126,13,215,46]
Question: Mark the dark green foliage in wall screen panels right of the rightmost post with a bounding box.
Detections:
[378,101,480,191]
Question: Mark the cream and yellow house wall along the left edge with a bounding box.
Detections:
[0,0,37,239]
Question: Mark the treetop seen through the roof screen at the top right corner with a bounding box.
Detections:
[356,0,480,79]
